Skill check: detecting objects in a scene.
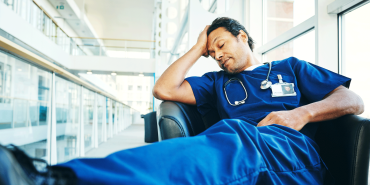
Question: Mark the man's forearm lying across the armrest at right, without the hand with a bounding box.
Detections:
[294,86,364,122]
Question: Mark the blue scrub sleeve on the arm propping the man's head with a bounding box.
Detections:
[185,73,216,115]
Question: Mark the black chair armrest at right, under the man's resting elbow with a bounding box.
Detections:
[315,115,370,185]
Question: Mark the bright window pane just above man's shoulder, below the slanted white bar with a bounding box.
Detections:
[263,30,315,63]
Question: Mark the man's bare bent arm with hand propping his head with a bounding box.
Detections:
[153,26,208,105]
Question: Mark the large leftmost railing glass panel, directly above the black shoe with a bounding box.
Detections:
[0,53,51,160]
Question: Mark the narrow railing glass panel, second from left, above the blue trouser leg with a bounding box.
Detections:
[55,77,80,163]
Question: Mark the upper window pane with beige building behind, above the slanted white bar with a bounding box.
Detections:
[263,0,315,43]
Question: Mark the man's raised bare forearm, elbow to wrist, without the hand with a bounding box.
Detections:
[153,45,203,99]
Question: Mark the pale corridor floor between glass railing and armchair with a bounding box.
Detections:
[85,124,148,157]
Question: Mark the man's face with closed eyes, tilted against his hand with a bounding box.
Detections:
[207,27,249,74]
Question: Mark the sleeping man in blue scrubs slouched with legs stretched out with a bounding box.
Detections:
[0,17,364,184]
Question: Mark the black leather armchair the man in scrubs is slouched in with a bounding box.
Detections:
[157,101,370,185]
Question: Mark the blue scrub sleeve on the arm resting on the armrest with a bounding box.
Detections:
[290,57,351,102]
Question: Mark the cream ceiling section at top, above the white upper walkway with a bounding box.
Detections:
[82,0,154,40]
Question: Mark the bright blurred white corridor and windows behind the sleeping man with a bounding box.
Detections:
[0,0,370,164]
